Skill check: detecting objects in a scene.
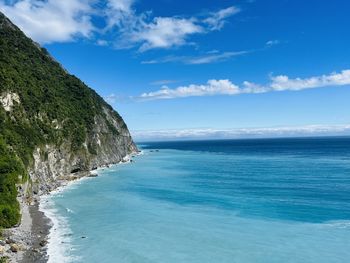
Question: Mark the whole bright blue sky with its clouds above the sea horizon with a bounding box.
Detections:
[0,0,350,140]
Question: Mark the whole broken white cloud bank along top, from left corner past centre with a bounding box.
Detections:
[0,0,240,52]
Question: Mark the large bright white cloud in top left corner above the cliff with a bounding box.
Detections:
[0,0,94,43]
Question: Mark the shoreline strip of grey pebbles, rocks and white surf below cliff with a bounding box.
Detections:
[1,151,142,263]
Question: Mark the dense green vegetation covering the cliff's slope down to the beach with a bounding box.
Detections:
[0,13,130,227]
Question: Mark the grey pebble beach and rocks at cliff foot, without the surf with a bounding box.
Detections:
[0,153,136,263]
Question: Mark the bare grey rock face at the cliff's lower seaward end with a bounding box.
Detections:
[28,105,138,195]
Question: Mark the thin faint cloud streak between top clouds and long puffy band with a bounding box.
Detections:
[141,51,247,65]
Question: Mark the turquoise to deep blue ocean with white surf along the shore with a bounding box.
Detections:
[41,137,350,263]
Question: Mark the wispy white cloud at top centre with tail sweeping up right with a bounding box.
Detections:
[106,5,239,52]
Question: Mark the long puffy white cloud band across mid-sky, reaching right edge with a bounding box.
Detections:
[137,70,350,100]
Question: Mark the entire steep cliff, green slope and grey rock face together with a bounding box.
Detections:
[0,13,137,226]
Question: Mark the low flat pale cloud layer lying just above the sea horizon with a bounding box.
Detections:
[132,124,350,141]
